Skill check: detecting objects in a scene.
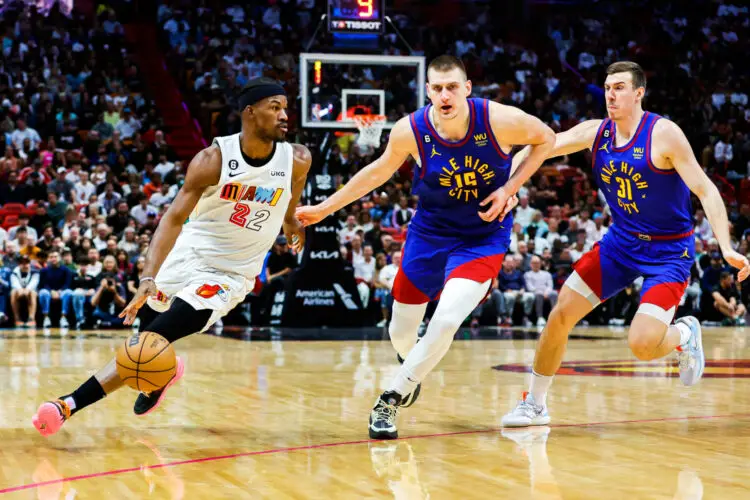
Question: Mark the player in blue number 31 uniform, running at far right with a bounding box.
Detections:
[502,61,750,427]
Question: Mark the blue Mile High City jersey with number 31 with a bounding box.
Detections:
[591,112,693,236]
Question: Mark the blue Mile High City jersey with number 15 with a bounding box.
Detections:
[409,98,513,238]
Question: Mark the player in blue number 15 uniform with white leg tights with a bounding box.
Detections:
[297,56,555,439]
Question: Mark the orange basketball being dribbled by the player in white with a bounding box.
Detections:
[115,332,177,392]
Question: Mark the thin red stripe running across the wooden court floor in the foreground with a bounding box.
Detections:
[0,413,750,494]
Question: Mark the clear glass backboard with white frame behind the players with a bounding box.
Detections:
[300,53,426,130]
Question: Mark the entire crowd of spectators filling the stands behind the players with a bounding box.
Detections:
[0,0,750,325]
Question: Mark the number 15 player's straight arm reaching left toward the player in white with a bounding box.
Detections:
[297,117,416,226]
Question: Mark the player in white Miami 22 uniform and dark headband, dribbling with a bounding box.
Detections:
[32,78,311,436]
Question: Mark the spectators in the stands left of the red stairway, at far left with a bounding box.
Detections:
[0,2,176,327]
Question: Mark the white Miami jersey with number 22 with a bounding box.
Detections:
[170,134,294,280]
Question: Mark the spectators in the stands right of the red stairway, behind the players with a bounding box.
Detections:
[159,0,750,325]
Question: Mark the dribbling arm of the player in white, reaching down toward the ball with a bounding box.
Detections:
[120,146,221,325]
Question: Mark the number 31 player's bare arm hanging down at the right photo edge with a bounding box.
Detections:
[664,118,750,281]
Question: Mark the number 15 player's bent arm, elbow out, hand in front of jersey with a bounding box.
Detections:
[477,102,555,222]
